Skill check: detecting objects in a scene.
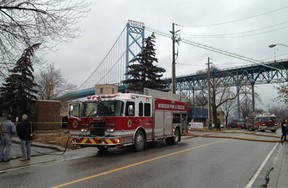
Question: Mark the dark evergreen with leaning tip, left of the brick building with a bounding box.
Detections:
[0,43,40,117]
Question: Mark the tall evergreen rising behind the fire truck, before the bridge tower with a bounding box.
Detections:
[123,33,168,92]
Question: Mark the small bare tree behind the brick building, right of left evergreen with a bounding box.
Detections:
[36,64,76,100]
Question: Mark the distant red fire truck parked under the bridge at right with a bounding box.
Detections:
[245,113,278,132]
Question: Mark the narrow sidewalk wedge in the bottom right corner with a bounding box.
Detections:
[268,142,288,188]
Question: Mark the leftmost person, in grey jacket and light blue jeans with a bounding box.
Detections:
[0,115,16,162]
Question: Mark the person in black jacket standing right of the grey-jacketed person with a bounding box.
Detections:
[17,114,33,161]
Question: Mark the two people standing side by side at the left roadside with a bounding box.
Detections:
[0,114,33,162]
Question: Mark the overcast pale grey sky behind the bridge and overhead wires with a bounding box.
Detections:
[45,0,288,110]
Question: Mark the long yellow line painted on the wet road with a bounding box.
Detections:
[52,139,228,188]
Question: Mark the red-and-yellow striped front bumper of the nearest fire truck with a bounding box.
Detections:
[71,137,122,146]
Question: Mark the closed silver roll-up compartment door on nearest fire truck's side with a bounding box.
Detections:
[154,110,172,136]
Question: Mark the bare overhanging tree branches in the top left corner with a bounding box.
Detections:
[0,0,89,77]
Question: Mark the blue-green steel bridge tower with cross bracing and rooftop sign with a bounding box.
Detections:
[125,20,145,79]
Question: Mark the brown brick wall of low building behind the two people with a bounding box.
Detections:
[31,100,61,130]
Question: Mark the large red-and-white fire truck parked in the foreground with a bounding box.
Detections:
[68,88,187,151]
